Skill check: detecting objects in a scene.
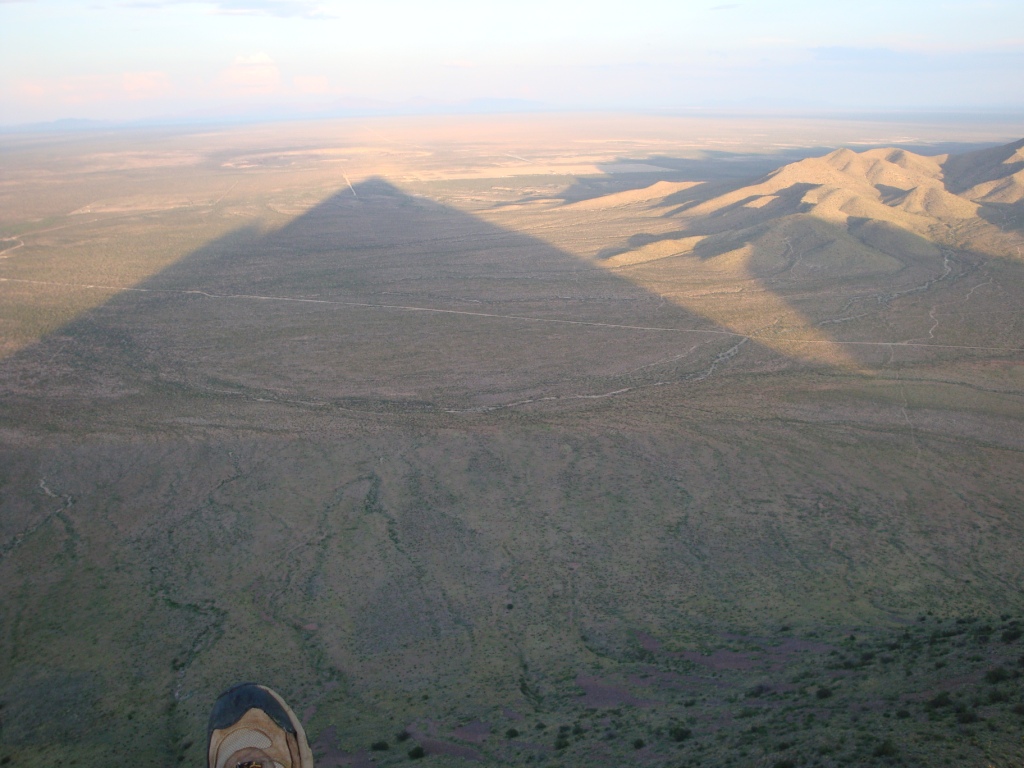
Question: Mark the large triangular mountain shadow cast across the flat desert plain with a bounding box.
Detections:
[0,179,864,428]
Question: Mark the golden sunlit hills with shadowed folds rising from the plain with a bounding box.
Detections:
[593,139,1024,276]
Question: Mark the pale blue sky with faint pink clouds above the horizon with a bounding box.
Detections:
[0,0,1024,125]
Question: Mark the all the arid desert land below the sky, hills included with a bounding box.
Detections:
[0,116,1024,768]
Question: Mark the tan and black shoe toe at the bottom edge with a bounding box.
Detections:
[207,683,313,768]
